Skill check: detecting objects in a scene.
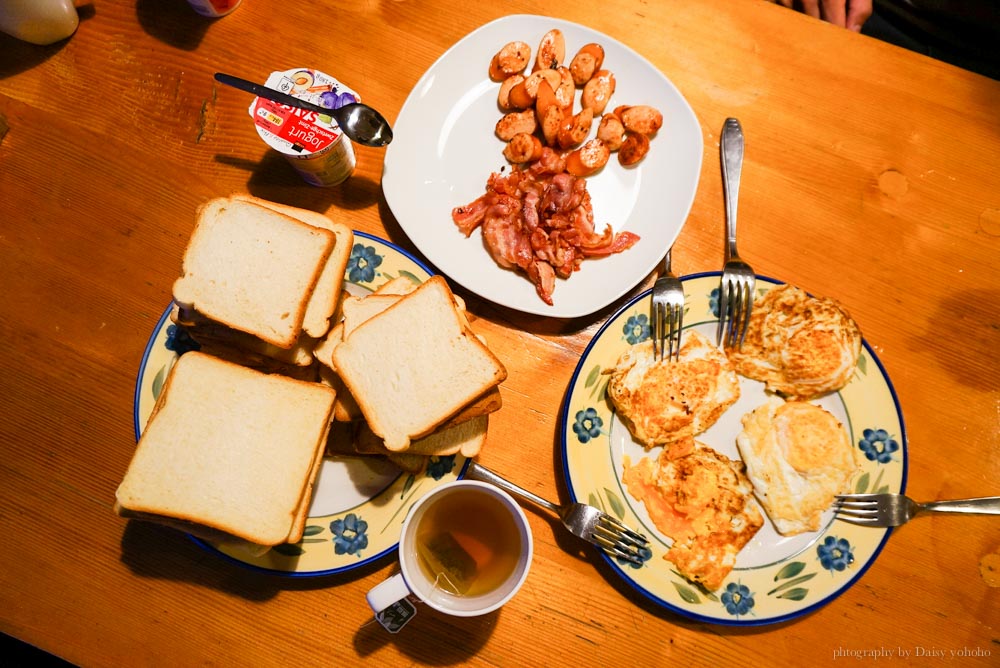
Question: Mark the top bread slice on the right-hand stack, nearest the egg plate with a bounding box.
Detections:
[333,276,507,452]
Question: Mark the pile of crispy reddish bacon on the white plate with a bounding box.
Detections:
[451,148,639,305]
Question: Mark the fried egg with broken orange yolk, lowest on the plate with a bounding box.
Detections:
[622,442,764,591]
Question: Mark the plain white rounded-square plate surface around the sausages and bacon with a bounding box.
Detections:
[382,15,703,318]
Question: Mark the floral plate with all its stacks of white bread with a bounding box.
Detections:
[131,196,506,576]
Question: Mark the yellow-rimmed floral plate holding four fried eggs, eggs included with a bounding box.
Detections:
[560,272,907,626]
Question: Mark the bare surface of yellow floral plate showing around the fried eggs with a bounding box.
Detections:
[561,272,907,625]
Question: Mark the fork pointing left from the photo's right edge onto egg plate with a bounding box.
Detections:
[833,494,1000,527]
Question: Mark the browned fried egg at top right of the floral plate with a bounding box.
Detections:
[728,285,861,400]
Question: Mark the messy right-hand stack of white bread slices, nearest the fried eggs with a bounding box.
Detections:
[314,276,507,472]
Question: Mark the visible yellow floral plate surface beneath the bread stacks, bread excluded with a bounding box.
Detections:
[134,232,465,576]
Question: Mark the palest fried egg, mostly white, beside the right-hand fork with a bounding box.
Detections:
[736,397,859,536]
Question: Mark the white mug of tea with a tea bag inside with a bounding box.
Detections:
[367,480,534,632]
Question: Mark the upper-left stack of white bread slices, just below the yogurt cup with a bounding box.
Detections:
[171,195,354,380]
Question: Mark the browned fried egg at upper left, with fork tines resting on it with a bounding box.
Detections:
[607,330,740,457]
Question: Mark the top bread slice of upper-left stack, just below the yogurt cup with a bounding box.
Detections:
[173,198,335,348]
